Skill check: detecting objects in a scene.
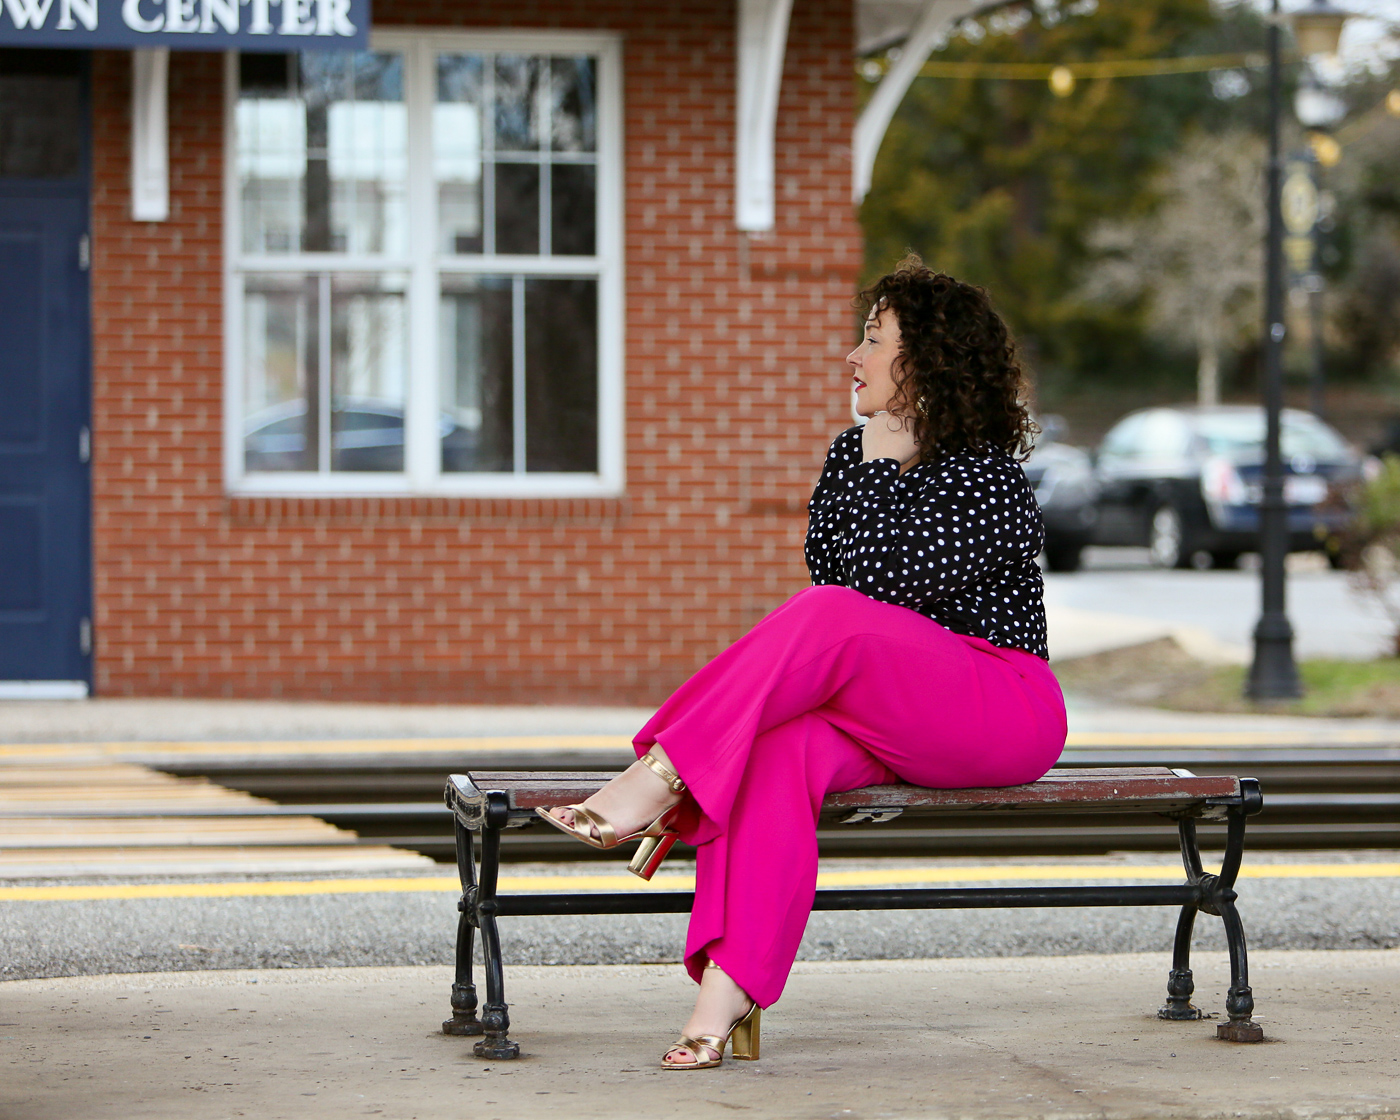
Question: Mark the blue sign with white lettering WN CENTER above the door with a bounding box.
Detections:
[0,0,370,52]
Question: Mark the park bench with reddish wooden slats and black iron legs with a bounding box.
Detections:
[442,766,1264,1060]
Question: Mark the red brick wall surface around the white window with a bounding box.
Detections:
[92,0,861,703]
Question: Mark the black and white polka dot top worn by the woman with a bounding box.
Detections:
[806,427,1050,659]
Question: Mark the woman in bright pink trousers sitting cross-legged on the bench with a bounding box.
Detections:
[540,258,1065,1070]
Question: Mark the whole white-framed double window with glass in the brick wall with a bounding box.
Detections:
[225,32,622,496]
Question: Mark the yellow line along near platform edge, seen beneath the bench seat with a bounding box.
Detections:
[0,864,1400,902]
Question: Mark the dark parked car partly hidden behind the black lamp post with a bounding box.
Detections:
[1093,405,1362,568]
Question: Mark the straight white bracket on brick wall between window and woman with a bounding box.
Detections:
[734,0,792,231]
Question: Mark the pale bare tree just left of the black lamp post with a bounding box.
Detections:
[1084,132,1266,405]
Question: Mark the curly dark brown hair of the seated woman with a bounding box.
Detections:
[855,253,1037,461]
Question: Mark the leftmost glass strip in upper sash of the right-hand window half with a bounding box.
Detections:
[433,55,482,253]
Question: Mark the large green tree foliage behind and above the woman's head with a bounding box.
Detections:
[861,0,1264,386]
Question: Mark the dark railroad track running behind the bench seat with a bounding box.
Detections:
[154,743,1400,861]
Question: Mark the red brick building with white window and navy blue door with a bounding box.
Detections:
[0,0,974,703]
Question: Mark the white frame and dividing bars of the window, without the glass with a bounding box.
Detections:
[224,28,626,498]
